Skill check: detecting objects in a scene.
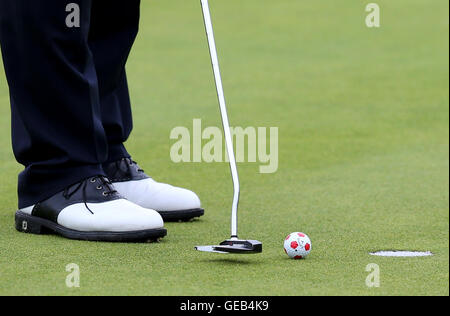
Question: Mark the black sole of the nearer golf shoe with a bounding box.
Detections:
[16,211,167,242]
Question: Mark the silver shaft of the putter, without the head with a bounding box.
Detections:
[201,0,240,240]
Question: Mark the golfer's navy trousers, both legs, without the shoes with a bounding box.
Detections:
[0,0,140,208]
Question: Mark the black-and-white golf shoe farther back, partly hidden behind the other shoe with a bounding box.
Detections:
[103,158,205,221]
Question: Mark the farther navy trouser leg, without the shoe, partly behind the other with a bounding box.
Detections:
[88,0,140,162]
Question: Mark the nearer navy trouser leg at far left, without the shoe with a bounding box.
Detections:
[0,0,108,208]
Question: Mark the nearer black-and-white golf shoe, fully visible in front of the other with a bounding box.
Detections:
[16,176,167,242]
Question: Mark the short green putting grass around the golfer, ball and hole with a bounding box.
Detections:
[0,0,449,295]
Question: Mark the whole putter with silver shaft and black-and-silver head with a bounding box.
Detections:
[195,0,262,254]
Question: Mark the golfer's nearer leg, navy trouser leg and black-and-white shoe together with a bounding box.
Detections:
[0,0,166,241]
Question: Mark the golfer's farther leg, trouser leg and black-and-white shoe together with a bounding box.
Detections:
[89,0,204,220]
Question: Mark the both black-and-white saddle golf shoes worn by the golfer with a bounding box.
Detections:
[16,158,204,242]
